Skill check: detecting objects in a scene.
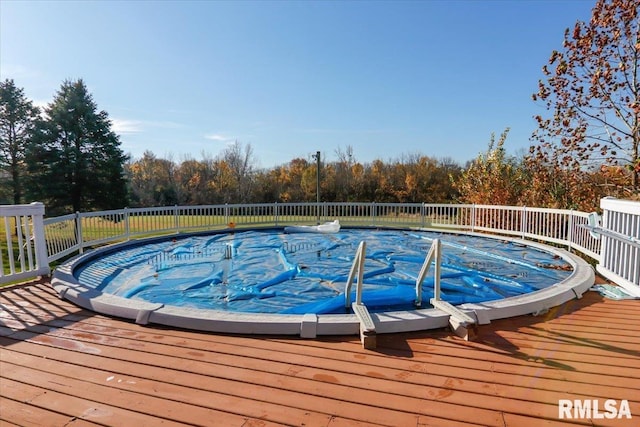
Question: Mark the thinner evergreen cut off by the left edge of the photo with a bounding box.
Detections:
[0,79,38,204]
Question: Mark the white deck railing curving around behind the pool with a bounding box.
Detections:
[0,198,640,289]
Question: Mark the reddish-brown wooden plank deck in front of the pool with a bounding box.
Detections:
[0,281,640,426]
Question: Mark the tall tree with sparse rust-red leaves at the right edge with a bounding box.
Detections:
[529,0,640,197]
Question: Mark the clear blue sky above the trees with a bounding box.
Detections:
[0,0,595,168]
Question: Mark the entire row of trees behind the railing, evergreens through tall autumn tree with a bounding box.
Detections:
[0,0,640,215]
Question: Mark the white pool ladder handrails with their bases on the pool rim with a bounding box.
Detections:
[344,239,477,349]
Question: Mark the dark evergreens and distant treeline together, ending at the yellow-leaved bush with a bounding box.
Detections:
[0,79,462,215]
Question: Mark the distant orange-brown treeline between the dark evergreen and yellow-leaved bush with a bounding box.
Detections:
[127,142,462,206]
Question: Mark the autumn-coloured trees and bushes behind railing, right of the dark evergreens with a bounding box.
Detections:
[125,123,638,211]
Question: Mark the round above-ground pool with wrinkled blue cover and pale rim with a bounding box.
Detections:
[52,228,593,333]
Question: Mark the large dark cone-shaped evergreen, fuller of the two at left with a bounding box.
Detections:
[27,80,127,214]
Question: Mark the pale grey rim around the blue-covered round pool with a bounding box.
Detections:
[51,227,595,338]
